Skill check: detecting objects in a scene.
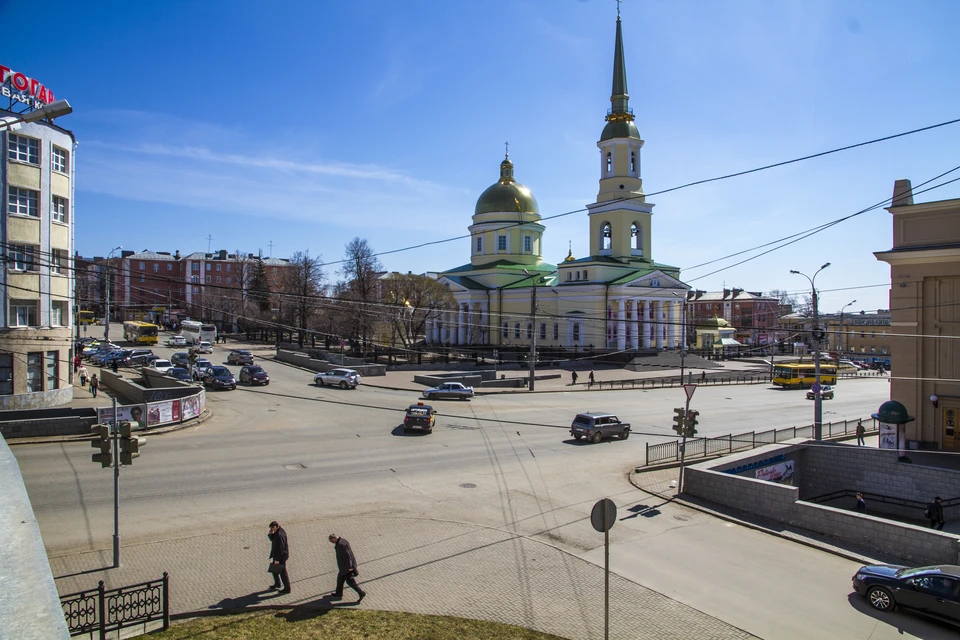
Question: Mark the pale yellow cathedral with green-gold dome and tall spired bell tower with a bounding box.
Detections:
[426,15,690,351]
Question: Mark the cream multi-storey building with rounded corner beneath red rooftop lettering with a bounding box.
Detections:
[0,110,77,410]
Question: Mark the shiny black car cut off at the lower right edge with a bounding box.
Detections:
[853,564,960,625]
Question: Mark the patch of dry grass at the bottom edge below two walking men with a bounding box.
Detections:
[150,607,563,640]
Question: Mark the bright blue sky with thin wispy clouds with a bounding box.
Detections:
[0,0,960,313]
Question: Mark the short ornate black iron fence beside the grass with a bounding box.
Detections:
[60,571,170,640]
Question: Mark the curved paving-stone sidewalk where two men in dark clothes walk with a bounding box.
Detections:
[50,516,755,640]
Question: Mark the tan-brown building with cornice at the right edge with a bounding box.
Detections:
[874,180,960,451]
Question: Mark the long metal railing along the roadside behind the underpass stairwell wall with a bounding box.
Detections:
[644,418,878,465]
